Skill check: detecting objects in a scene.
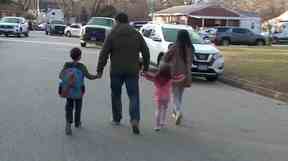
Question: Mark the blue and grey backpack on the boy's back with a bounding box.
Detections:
[58,68,84,99]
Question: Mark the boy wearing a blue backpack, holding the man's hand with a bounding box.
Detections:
[58,48,98,135]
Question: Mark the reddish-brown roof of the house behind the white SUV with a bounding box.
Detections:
[155,5,240,17]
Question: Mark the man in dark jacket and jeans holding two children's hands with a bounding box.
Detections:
[97,13,150,135]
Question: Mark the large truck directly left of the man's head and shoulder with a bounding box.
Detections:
[80,17,115,47]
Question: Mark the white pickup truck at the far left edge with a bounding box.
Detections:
[0,17,29,37]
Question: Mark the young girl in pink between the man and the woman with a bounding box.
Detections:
[144,64,185,131]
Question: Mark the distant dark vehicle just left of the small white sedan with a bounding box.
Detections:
[45,20,66,35]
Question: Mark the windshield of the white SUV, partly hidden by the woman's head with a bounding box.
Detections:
[162,27,204,44]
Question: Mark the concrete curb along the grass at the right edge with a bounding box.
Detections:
[219,77,288,102]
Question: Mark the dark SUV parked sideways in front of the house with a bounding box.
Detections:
[212,27,266,46]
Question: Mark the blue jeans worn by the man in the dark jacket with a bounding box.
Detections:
[111,74,140,123]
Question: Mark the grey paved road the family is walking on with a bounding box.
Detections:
[0,33,288,161]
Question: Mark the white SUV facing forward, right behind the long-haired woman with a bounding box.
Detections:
[140,24,224,81]
